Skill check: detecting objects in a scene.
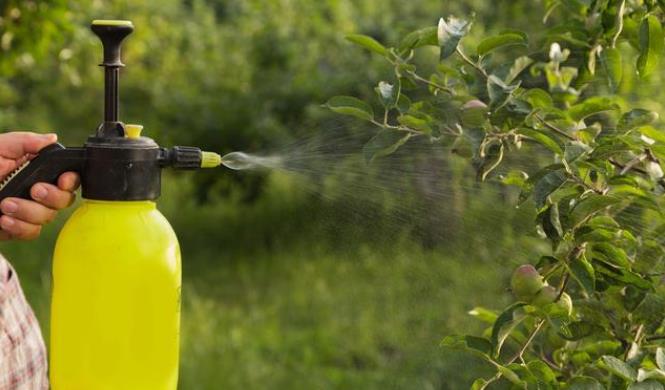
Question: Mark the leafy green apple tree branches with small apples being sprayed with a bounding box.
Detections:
[326,0,665,389]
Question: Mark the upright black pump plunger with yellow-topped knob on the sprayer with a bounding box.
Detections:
[90,20,134,138]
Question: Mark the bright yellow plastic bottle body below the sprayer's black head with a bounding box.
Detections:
[50,200,181,390]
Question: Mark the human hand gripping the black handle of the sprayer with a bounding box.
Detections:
[0,132,80,240]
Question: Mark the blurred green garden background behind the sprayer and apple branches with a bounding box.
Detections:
[0,0,546,389]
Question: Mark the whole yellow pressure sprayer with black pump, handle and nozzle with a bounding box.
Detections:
[0,20,221,390]
